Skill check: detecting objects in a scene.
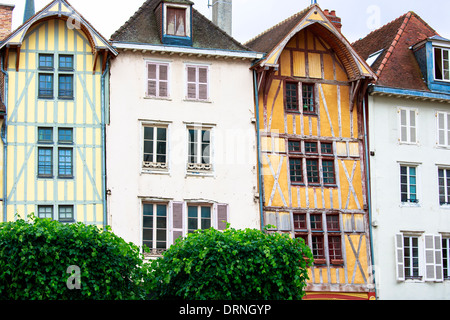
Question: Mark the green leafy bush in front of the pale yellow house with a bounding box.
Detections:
[0,217,151,300]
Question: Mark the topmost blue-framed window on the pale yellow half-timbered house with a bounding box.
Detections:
[38,54,74,99]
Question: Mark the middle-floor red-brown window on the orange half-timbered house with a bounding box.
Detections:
[288,140,336,186]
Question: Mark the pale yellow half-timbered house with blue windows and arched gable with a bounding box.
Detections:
[0,0,117,226]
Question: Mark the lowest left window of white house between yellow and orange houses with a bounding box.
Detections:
[142,203,168,251]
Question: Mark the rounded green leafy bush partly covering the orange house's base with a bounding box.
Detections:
[149,228,312,300]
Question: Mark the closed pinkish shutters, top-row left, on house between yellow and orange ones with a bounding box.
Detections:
[147,62,169,98]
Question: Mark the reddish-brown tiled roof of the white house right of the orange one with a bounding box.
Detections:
[353,11,438,91]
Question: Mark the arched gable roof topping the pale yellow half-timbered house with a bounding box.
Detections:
[0,0,118,55]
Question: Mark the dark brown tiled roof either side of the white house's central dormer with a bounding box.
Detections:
[111,0,251,51]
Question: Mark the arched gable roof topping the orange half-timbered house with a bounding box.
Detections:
[245,4,376,80]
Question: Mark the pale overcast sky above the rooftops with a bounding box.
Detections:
[5,0,450,43]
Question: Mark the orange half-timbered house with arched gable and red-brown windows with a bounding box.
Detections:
[246,5,376,299]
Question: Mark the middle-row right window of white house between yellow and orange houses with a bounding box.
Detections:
[188,127,212,171]
